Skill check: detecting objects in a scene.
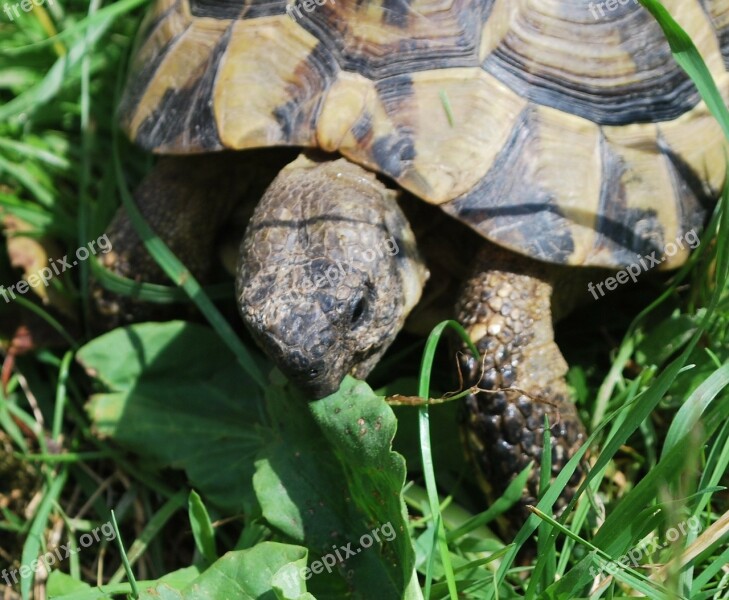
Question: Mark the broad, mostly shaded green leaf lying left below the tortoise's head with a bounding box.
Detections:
[78,321,264,513]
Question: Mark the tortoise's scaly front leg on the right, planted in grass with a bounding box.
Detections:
[457,244,585,526]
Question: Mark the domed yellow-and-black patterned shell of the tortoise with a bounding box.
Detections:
[121,0,729,268]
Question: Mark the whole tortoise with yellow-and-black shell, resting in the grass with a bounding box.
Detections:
[102,0,729,524]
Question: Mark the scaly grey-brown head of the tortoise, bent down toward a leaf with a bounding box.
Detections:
[237,155,427,398]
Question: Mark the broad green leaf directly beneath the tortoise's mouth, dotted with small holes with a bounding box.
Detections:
[254,378,414,599]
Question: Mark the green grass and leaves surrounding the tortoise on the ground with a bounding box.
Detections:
[0,0,729,600]
